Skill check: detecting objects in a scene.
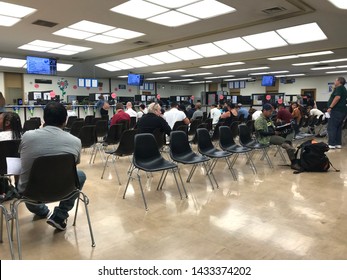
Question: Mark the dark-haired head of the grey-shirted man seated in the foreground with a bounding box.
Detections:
[43,101,67,127]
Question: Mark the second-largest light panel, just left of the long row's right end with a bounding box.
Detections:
[242,31,288,50]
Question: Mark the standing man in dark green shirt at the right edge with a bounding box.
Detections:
[327,77,347,149]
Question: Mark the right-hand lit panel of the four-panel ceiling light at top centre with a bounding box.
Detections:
[177,0,236,19]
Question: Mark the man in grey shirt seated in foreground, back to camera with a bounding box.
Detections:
[18,102,86,230]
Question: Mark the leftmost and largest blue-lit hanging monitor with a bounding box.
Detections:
[27,56,57,75]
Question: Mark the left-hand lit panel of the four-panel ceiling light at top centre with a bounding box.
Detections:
[111,0,169,19]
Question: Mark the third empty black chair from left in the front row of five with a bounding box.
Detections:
[197,128,236,189]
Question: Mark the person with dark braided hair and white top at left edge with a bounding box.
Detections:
[0,112,22,141]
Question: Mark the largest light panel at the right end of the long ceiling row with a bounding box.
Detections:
[276,22,328,44]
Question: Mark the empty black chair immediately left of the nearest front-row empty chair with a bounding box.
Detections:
[101,130,137,185]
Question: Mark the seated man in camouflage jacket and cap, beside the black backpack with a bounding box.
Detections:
[254,103,300,169]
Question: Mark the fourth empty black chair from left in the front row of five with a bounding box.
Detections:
[219,126,257,174]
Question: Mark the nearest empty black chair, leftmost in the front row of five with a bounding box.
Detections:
[123,133,188,210]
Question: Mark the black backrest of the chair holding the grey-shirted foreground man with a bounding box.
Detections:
[22,154,79,202]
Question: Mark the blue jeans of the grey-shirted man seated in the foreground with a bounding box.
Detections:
[25,170,87,220]
